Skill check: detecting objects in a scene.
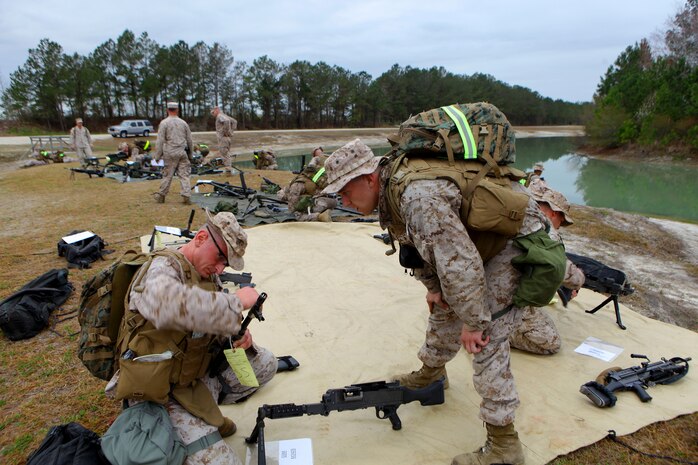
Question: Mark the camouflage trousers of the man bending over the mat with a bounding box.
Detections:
[418,241,524,426]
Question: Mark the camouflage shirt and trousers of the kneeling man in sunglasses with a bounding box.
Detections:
[114,257,278,465]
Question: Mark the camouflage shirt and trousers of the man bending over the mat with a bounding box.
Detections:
[378,170,545,426]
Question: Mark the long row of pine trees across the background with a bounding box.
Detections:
[2,30,585,130]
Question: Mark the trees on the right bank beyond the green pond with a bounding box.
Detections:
[586,0,698,150]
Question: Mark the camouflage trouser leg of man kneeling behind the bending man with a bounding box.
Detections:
[509,307,562,355]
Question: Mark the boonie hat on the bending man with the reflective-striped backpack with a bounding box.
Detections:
[322,139,380,194]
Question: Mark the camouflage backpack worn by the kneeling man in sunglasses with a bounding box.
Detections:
[78,250,152,381]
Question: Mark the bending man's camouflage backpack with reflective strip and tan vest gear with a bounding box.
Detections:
[385,102,529,261]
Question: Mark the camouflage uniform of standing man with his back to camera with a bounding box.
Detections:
[153,116,194,200]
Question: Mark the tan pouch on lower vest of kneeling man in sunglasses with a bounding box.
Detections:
[116,359,173,404]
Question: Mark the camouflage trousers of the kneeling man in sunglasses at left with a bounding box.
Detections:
[166,346,278,465]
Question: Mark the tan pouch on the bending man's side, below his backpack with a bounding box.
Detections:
[466,179,528,237]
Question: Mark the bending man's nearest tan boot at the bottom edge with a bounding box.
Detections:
[451,423,524,465]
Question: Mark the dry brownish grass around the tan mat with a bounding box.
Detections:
[0,139,698,465]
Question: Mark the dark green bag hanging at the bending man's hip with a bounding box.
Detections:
[511,230,567,308]
